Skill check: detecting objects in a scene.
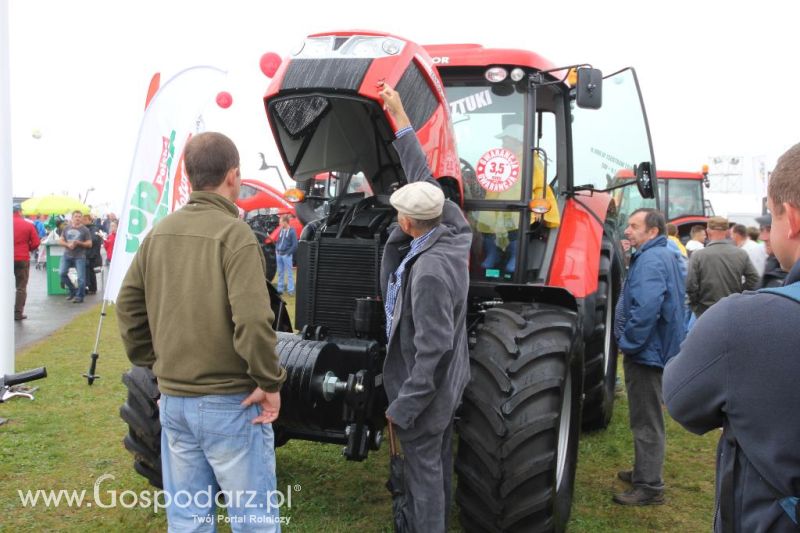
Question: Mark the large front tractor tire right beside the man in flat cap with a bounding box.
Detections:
[455,304,583,533]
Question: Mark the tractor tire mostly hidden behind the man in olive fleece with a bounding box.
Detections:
[119,283,292,488]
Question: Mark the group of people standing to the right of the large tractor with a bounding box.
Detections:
[613,144,800,531]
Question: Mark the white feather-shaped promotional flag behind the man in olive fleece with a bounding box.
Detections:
[104,66,226,302]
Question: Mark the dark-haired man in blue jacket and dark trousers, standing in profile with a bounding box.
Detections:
[614,209,686,505]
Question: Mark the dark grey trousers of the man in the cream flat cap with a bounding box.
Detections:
[398,421,453,533]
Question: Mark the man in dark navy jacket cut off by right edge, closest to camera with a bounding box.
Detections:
[664,144,800,532]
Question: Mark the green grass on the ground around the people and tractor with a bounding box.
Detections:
[0,302,718,533]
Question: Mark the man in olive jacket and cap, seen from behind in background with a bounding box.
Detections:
[686,217,761,318]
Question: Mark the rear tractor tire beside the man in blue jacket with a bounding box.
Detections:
[582,224,624,431]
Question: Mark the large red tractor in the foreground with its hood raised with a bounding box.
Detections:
[123,31,655,532]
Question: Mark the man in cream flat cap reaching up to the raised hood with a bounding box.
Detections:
[380,85,472,533]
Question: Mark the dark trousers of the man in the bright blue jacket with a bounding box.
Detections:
[623,356,666,489]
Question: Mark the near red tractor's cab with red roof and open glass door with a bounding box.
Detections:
[426,44,655,290]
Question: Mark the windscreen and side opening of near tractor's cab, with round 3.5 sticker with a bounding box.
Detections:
[444,80,563,286]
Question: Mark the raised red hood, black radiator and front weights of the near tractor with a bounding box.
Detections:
[264,33,462,460]
